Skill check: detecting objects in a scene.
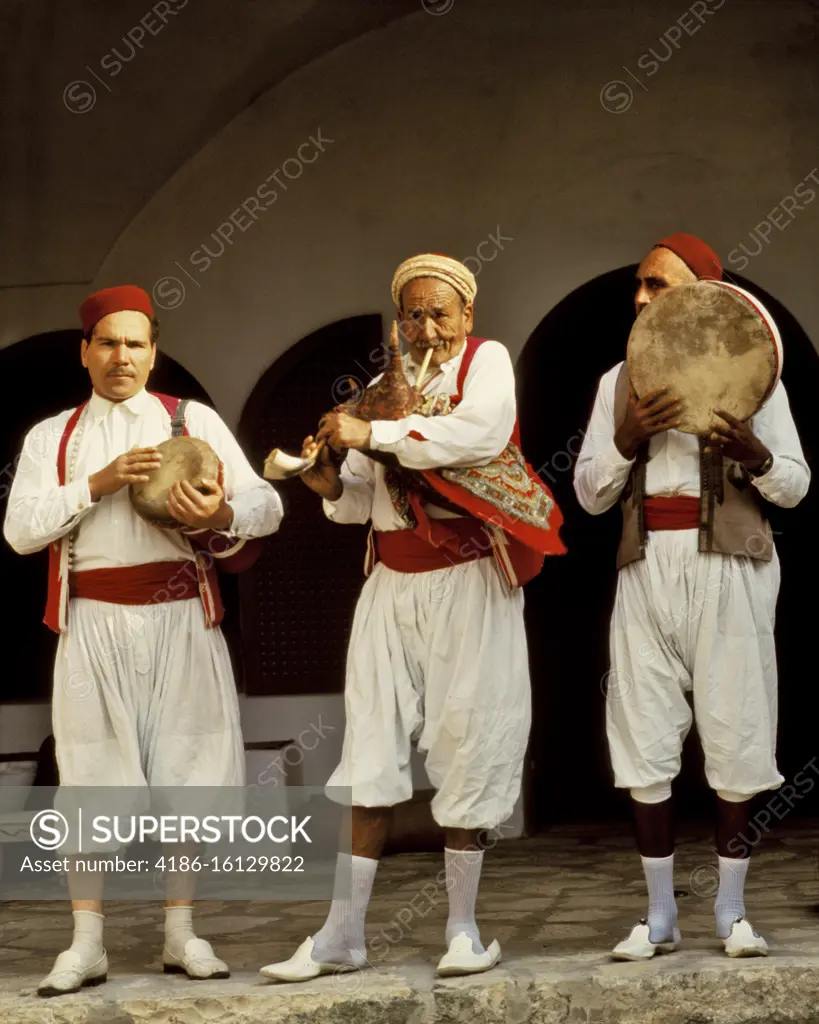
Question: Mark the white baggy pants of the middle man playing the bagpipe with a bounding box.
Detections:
[328,558,531,828]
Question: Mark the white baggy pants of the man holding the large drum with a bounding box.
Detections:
[606,529,784,796]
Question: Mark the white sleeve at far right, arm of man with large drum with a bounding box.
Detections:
[750,381,811,508]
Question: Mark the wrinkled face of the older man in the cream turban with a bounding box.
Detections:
[398,278,473,367]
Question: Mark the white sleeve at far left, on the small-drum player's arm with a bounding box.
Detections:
[0,422,93,555]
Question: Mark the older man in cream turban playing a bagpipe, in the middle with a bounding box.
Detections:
[262,254,565,981]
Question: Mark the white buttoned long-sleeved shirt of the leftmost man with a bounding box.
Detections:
[3,390,283,571]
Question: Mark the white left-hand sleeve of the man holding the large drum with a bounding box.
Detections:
[574,368,634,515]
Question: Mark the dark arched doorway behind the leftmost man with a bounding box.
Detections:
[0,331,222,700]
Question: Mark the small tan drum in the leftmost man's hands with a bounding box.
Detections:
[128,437,221,529]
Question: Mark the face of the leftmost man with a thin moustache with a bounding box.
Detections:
[81,309,157,401]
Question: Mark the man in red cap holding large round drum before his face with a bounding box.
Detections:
[574,234,810,961]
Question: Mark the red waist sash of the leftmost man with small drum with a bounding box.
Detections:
[69,561,200,604]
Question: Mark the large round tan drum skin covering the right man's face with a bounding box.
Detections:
[627,281,781,434]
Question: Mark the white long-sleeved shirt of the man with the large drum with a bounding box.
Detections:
[574,362,811,515]
